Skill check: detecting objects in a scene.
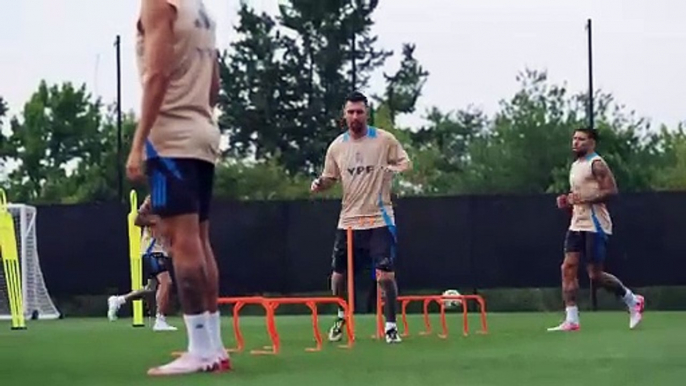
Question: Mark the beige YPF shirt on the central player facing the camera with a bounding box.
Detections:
[334,127,393,229]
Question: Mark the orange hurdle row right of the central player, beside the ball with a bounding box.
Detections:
[377,295,488,338]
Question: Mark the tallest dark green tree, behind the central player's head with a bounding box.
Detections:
[220,0,391,173]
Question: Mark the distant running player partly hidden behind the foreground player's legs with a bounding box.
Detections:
[107,196,177,331]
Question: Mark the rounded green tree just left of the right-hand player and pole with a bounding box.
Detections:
[463,70,583,193]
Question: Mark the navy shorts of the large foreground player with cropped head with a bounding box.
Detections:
[146,157,214,222]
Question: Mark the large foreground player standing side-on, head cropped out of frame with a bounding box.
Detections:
[126,0,230,375]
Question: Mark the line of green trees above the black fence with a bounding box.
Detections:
[0,0,686,203]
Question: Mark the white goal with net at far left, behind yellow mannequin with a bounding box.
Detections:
[0,204,60,320]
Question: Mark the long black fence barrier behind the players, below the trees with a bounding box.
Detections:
[30,193,686,296]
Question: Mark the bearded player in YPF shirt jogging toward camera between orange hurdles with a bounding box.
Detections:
[311,92,411,343]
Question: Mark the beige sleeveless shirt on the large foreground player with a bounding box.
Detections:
[136,0,219,162]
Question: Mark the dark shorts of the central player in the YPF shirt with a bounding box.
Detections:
[331,226,396,274]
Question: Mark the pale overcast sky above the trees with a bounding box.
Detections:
[0,0,686,131]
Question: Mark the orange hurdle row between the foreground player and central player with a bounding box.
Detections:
[218,296,355,355]
